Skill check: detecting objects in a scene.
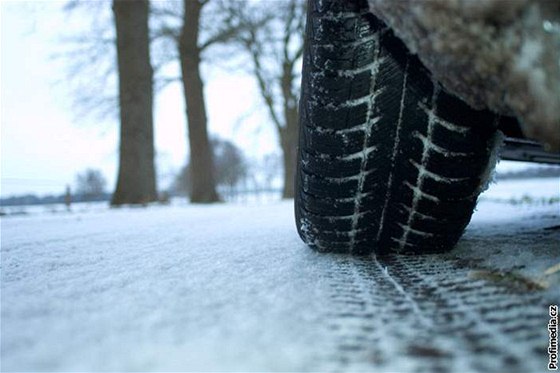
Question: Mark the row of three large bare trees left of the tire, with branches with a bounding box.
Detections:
[68,0,305,205]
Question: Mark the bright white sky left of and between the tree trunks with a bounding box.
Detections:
[0,1,279,197]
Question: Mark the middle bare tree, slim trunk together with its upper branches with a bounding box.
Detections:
[136,0,247,203]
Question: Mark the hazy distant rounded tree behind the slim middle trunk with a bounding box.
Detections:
[174,138,248,195]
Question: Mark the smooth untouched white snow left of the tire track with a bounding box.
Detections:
[2,203,328,371]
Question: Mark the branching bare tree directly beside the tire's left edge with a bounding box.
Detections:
[223,0,306,198]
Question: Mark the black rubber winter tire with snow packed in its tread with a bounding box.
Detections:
[295,0,498,254]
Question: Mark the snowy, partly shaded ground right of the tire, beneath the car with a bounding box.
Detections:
[454,178,560,290]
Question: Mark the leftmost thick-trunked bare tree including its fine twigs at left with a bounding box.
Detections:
[60,0,156,205]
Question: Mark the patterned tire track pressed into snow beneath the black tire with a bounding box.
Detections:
[321,255,548,372]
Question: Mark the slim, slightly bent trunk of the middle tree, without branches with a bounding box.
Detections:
[179,0,220,203]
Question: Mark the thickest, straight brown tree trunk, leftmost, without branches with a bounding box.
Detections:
[111,0,157,205]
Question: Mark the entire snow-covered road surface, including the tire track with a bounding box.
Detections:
[1,179,560,372]
